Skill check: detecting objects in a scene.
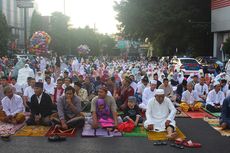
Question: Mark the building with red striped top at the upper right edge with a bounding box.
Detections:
[211,0,230,61]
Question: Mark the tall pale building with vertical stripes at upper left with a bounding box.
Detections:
[0,0,34,49]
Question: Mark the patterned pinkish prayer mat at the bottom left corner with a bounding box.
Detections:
[0,122,25,136]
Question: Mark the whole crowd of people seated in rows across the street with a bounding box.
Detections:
[0,56,230,138]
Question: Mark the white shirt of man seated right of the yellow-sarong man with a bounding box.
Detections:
[206,89,225,106]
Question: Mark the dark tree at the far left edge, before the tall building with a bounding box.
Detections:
[0,12,10,55]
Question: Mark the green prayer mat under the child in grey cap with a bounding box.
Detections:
[123,126,147,137]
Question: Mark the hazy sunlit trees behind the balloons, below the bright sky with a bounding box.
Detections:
[31,12,115,55]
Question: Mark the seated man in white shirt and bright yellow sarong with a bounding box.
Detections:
[180,82,202,112]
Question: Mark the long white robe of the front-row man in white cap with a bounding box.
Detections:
[144,97,176,132]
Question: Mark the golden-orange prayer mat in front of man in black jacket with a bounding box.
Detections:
[15,125,50,137]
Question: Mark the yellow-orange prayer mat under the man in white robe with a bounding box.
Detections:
[148,128,186,141]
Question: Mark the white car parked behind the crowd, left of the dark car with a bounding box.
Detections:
[171,57,203,76]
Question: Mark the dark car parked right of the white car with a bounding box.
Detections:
[196,56,224,73]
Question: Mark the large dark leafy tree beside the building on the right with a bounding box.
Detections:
[114,0,212,55]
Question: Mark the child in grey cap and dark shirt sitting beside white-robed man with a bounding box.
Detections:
[123,96,143,126]
